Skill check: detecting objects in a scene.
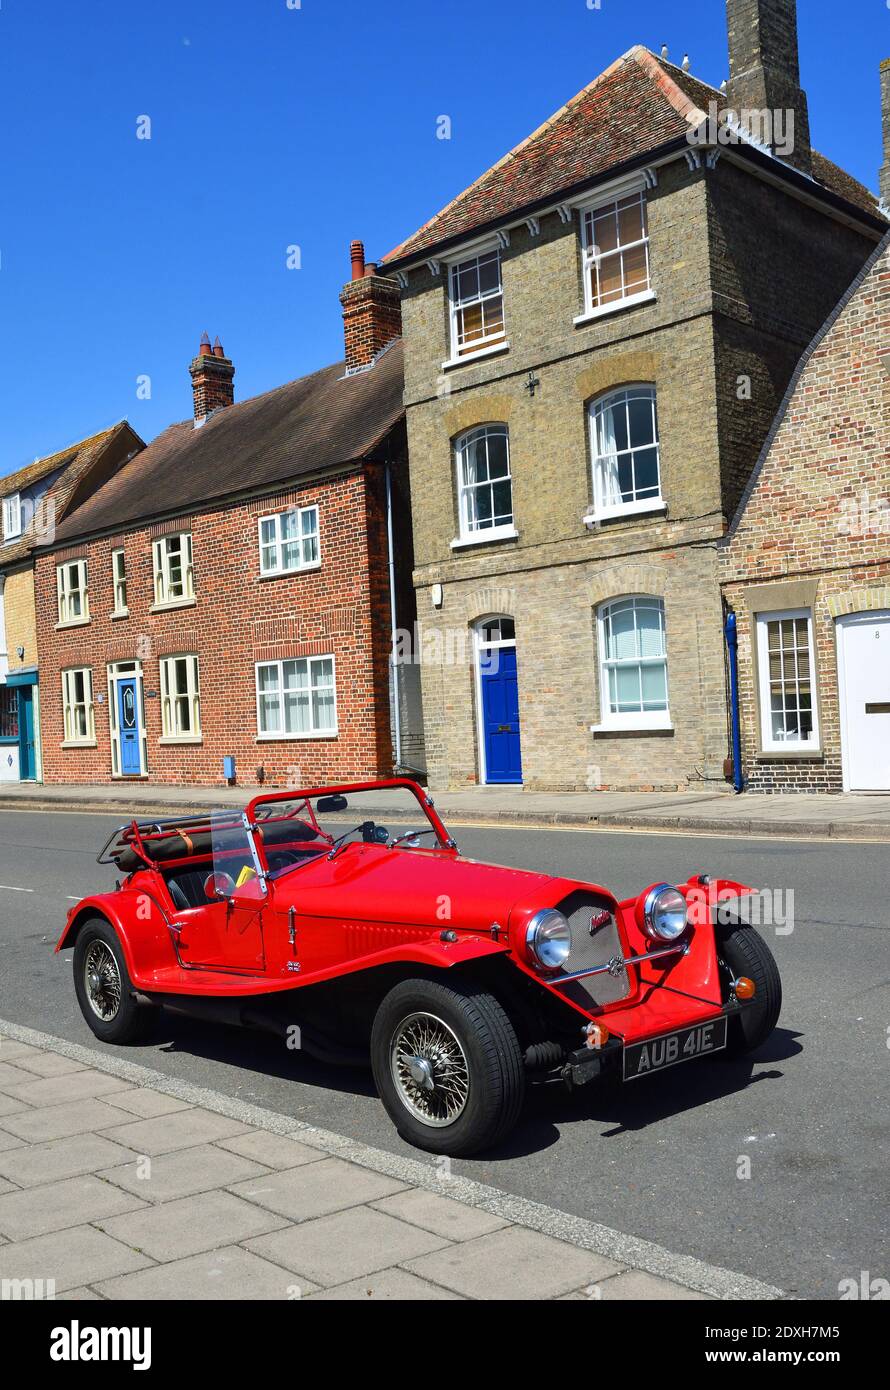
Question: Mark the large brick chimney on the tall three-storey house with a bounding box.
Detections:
[726,0,812,174]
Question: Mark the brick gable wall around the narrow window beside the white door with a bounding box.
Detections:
[722,233,890,792]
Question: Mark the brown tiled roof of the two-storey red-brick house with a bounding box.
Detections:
[56,341,405,542]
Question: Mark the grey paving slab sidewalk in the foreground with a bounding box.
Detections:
[0,1020,784,1300]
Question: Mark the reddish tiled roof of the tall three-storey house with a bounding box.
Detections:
[381,46,877,267]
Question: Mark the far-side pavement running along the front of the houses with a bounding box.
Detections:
[0,783,890,842]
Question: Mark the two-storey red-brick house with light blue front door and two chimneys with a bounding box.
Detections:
[36,255,423,785]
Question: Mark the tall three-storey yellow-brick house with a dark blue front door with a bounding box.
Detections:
[381,0,887,790]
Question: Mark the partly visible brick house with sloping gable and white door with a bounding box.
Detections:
[720,230,890,792]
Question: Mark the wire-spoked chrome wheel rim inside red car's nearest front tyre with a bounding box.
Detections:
[389,1013,470,1129]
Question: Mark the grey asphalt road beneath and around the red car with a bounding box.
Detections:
[0,810,890,1298]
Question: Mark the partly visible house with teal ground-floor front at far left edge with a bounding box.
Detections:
[0,421,145,781]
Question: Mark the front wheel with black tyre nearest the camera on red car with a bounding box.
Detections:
[371,980,526,1156]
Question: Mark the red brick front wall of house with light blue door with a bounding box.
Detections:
[35,467,392,785]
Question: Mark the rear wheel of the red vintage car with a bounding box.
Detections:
[74,917,156,1044]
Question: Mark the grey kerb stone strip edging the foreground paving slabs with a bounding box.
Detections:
[0,1019,790,1301]
